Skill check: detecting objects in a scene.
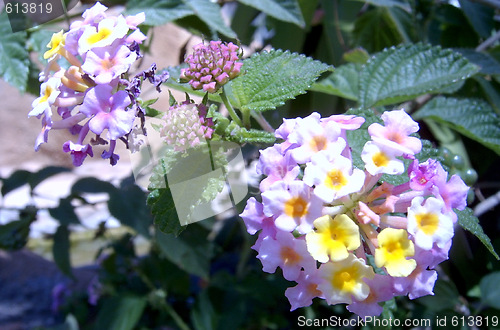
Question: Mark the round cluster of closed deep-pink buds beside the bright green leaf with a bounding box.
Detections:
[181,41,243,93]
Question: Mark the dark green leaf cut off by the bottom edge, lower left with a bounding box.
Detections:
[94,295,147,330]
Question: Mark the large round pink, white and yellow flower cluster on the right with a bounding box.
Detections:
[241,110,468,317]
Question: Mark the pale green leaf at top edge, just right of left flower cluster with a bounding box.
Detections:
[126,0,194,26]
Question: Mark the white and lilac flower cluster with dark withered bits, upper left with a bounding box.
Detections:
[28,2,165,166]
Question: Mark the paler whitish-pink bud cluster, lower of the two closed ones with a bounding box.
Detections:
[160,100,214,151]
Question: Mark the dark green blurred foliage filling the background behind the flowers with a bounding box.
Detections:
[0,0,500,329]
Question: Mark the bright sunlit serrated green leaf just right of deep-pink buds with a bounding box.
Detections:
[226,50,330,112]
